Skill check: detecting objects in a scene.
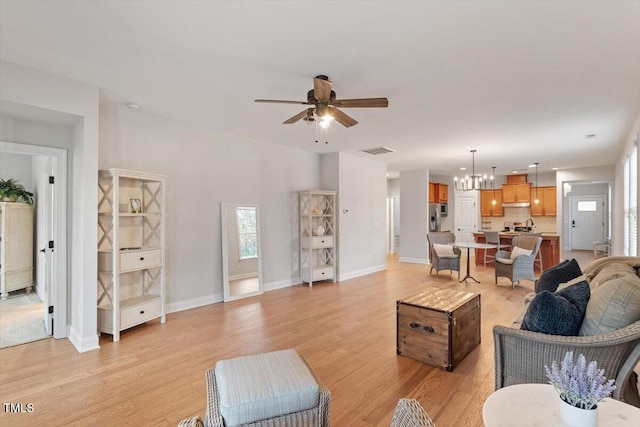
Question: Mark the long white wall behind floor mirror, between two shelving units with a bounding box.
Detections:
[99,106,320,312]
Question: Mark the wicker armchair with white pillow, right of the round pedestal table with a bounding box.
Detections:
[496,236,542,288]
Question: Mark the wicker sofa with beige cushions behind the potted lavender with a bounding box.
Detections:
[493,257,640,407]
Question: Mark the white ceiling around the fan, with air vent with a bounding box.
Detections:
[0,0,640,175]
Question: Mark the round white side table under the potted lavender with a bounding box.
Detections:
[482,384,640,427]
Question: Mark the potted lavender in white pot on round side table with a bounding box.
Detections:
[544,351,616,427]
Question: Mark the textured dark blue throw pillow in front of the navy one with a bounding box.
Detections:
[520,280,591,336]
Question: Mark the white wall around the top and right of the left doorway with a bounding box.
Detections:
[0,61,98,352]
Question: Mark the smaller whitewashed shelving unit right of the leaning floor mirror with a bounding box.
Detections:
[299,190,338,287]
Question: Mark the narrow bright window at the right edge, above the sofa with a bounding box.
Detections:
[624,147,638,256]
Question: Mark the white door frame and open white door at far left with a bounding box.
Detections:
[0,141,67,345]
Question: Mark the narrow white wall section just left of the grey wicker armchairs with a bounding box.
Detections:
[399,170,429,264]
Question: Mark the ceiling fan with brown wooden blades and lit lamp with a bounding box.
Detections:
[255,75,389,127]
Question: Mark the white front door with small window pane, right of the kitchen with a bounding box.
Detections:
[569,196,605,250]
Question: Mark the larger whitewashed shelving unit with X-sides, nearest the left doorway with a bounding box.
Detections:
[98,169,167,341]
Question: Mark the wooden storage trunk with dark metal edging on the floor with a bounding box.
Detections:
[396,288,480,371]
